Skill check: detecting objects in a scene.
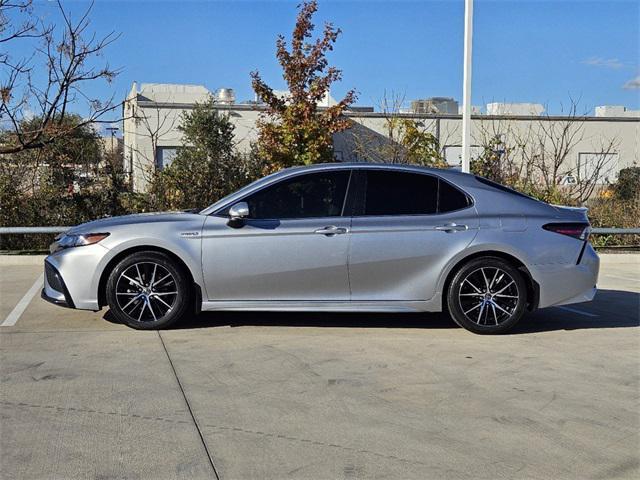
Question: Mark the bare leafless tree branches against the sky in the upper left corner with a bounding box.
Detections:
[0,0,119,154]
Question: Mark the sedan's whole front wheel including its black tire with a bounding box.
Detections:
[106,252,192,330]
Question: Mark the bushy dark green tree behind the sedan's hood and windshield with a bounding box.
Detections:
[151,98,263,209]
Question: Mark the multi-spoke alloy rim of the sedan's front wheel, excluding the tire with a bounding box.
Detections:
[115,262,178,322]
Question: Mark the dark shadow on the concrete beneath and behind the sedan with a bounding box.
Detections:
[103,290,640,335]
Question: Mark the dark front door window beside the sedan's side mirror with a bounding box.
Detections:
[245,170,350,219]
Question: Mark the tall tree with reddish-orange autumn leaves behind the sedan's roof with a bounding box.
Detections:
[251,0,356,170]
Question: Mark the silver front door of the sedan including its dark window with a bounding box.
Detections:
[202,169,351,301]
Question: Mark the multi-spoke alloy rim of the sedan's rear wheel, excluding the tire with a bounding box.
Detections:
[458,267,520,326]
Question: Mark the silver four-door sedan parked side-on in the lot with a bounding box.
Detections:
[42,163,599,333]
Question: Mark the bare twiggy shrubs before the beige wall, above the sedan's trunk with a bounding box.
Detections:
[472,99,619,204]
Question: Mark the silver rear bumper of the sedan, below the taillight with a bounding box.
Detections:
[531,244,600,308]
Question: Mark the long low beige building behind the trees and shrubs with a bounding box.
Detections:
[123,83,640,191]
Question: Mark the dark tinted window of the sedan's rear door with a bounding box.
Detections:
[364,170,438,215]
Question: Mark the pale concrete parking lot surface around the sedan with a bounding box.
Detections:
[0,255,640,479]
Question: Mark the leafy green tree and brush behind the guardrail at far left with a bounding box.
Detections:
[0,113,130,249]
